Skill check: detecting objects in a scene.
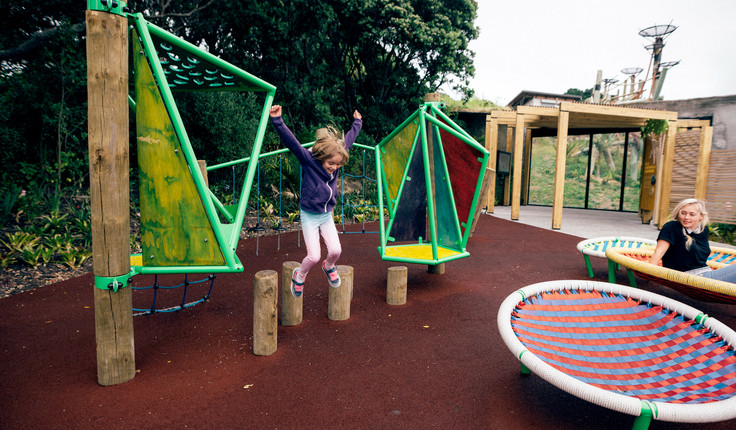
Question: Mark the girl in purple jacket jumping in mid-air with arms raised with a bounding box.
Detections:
[269,105,363,298]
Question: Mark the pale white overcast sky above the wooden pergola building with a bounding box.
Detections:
[460,0,736,106]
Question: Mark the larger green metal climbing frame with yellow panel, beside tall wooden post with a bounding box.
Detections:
[128,14,276,274]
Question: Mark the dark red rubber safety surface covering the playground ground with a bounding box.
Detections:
[0,216,736,429]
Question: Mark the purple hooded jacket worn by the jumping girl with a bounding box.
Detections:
[271,116,363,213]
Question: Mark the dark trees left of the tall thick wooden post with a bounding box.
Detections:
[0,0,87,193]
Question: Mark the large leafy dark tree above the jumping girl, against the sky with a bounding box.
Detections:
[189,0,478,136]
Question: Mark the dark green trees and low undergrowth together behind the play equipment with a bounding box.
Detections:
[0,0,478,268]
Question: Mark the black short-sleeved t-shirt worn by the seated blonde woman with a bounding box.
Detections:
[657,221,710,272]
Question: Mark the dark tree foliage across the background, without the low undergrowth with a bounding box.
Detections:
[0,0,478,198]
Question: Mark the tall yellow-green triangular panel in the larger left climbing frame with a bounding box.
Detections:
[134,33,225,267]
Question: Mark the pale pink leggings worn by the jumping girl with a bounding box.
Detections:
[299,210,342,280]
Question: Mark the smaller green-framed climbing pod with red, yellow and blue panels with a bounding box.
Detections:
[376,102,489,265]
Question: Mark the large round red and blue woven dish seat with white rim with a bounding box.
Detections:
[498,281,736,429]
